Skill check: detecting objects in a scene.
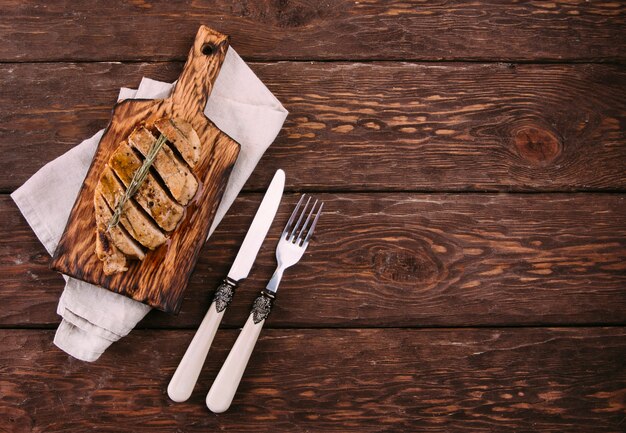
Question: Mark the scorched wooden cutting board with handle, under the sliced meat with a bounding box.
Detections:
[51,26,239,313]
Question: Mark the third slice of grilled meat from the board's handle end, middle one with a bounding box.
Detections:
[109,141,184,231]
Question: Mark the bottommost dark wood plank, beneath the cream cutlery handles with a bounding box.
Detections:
[0,328,626,433]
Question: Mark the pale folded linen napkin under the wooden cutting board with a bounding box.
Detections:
[11,48,287,362]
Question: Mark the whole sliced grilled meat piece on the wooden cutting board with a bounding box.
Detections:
[94,118,200,275]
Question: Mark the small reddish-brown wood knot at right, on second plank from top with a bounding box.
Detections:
[513,125,562,165]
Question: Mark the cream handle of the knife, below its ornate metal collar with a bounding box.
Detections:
[167,302,226,402]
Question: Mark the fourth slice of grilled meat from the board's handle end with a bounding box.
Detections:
[96,165,167,250]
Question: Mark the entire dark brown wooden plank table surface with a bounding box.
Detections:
[0,0,626,433]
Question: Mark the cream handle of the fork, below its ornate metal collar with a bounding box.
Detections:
[206,314,265,413]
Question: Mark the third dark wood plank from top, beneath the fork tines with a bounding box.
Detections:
[0,194,626,327]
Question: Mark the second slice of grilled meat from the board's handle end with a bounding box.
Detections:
[128,127,198,206]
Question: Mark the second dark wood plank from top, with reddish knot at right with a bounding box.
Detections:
[0,63,626,191]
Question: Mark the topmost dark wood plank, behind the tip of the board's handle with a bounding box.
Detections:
[0,0,626,61]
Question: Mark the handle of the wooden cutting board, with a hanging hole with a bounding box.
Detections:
[170,26,228,113]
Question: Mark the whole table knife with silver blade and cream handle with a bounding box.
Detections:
[167,170,285,402]
